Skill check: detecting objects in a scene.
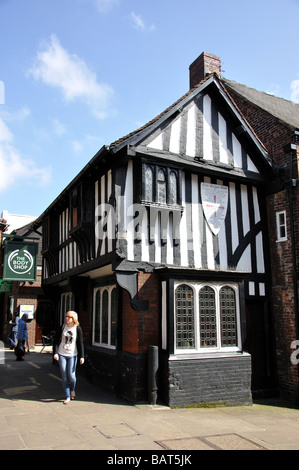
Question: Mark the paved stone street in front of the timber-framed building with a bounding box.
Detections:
[0,348,299,452]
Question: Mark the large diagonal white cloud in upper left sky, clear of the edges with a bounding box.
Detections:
[29,35,113,118]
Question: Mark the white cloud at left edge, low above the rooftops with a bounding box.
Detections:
[0,119,51,192]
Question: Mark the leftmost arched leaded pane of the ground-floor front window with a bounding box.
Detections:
[175,284,195,349]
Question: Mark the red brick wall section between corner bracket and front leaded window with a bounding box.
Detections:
[122,273,159,354]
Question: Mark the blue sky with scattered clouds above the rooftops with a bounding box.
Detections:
[0,0,299,216]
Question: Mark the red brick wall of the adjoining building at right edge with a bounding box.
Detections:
[229,89,299,401]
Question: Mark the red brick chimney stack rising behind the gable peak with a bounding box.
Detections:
[189,52,221,89]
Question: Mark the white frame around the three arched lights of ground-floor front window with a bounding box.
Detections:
[173,281,242,355]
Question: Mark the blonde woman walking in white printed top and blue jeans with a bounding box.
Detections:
[53,311,84,405]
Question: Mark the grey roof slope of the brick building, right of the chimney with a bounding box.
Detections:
[221,77,299,129]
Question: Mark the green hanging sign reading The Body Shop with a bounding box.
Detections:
[3,241,38,281]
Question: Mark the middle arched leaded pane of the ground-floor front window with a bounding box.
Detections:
[199,286,217,348]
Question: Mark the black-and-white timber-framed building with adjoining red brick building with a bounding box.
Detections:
[33,53,299,406]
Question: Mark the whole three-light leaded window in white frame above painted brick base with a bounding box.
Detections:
[174,282,241,352]
